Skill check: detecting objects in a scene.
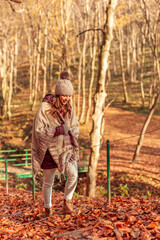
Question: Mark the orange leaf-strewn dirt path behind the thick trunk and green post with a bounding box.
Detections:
[80,108,160,195]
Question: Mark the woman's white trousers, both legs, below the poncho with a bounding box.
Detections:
[42,161,78,208]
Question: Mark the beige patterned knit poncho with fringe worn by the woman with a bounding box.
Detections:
[32,102,79,175]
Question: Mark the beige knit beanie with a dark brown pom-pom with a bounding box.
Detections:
[55,71,73,95]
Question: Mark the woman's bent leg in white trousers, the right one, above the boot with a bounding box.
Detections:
[64,161,78,200]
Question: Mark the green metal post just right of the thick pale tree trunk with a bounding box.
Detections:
[107,140,111,204]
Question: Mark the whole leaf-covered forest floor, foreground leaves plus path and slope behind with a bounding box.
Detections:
[0,96,160,240]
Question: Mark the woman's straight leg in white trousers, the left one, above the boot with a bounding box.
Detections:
[42,168,56,208]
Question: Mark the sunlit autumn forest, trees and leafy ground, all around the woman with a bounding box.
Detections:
[0,0,160,239]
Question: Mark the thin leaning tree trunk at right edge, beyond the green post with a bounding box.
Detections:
[132,94,159,162]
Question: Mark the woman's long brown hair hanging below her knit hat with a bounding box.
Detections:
[47,95,72,118]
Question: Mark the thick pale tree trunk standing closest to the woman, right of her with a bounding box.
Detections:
[87,0,117,197]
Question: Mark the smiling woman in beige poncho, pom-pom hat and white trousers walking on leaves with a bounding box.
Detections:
[32,71,79,216]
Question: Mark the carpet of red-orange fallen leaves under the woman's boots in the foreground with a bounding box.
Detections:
[0,188,160,240]
